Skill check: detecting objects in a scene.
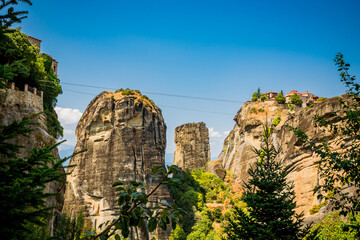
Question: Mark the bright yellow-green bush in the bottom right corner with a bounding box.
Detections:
[304,212,360,240]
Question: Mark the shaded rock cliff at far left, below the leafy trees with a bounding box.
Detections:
[0,86,65,232]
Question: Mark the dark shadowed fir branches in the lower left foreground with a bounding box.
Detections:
[0,115,74,239]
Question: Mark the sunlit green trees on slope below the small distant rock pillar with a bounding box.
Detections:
[170,168,232,240]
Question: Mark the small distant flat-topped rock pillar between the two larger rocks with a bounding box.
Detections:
[174,122,210,170]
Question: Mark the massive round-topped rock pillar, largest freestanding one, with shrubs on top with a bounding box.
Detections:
[64,92,171,239]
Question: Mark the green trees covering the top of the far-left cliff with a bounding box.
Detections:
[0,29,63,138]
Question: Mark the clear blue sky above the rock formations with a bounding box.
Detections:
[15,0,360,161]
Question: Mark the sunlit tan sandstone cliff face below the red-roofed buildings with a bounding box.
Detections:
[218,96,347,218]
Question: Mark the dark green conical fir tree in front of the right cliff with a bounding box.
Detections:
[224,126,306,239]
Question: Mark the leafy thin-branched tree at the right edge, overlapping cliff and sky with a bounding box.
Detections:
[290,53,360,215]
